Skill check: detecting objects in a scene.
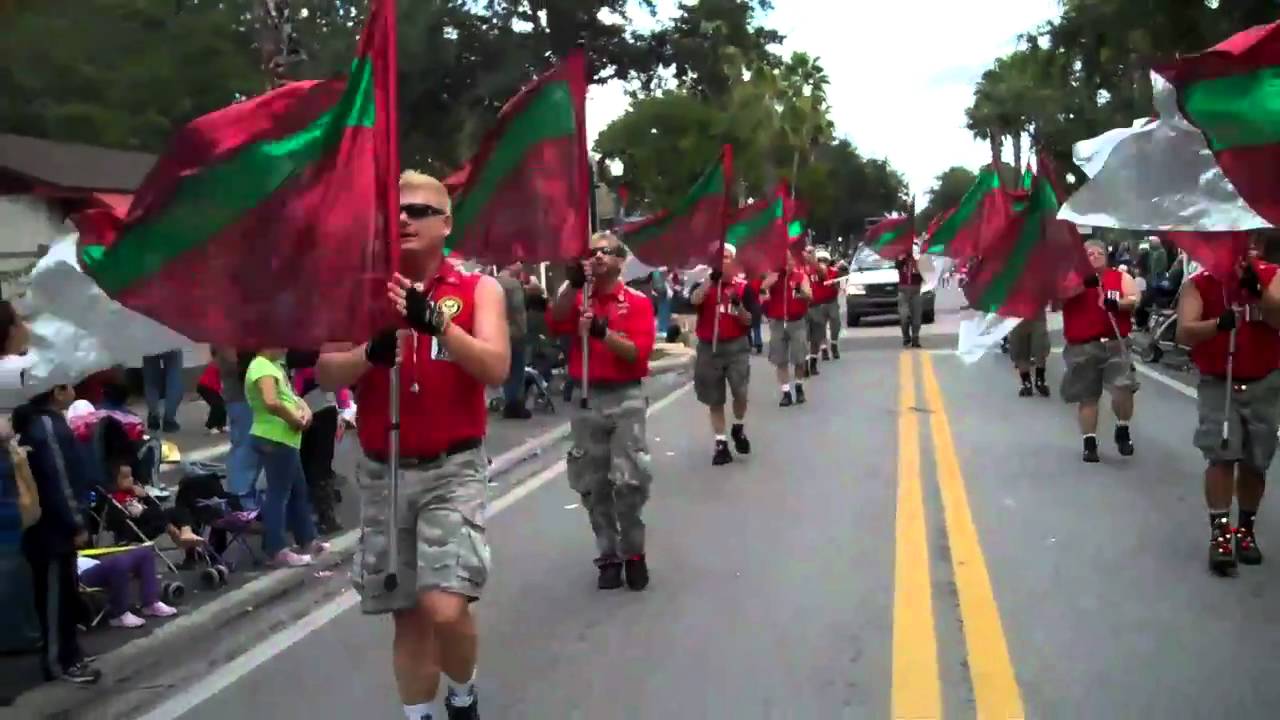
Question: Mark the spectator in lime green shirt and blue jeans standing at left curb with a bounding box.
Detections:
[244,348,325,566]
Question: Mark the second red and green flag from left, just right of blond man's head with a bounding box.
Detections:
[444,50,591,265]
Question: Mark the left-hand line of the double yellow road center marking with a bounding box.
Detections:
[892,352,942,717]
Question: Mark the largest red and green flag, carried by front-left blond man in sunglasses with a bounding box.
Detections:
[79,0,399,348]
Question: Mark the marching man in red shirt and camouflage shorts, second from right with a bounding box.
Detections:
[1059,240,1138,462]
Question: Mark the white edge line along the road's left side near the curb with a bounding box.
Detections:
[142,383,694,720]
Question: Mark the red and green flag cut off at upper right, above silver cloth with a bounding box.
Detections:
[1156,22,1280,224]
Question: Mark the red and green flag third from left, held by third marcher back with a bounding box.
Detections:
[618,145,733,268]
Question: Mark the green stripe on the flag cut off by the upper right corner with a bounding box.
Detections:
[1180,67,1280,151]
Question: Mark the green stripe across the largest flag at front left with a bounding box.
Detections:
[82,58,378,293]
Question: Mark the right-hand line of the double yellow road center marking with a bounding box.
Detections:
[922,355,1025,720]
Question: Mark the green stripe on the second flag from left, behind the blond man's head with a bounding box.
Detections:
[448,81,577,246]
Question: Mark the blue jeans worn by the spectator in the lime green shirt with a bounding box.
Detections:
[253,437,316,557]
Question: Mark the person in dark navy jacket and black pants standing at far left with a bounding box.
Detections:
[13,386,102,683]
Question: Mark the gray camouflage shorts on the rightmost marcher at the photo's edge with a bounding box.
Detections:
[1194,372,1280,471]
